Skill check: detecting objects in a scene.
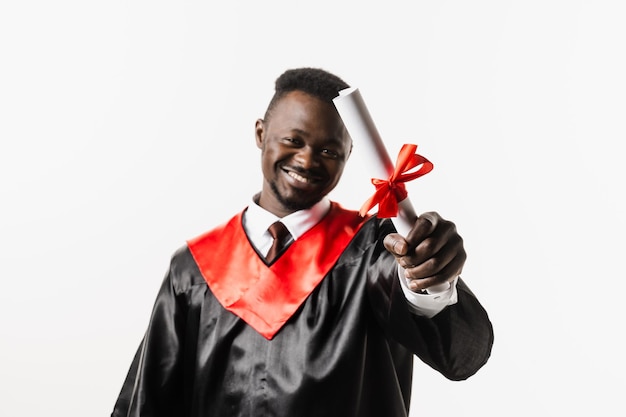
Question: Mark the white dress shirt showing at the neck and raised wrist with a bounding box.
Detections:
[243,198,458,318]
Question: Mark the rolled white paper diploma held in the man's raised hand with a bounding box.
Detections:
[333,87,450,293]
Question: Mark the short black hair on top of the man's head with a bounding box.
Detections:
[265,67,350,119]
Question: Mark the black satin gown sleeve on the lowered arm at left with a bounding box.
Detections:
[111,249,206,417]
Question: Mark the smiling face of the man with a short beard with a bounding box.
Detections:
[256,91,351,217]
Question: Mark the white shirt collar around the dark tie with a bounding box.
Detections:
[243,196,330,241]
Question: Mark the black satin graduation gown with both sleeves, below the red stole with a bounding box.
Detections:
[112,217,493,417]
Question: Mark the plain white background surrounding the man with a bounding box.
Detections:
[0,0,626,417]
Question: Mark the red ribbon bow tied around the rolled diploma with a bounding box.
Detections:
[360,144,433,218]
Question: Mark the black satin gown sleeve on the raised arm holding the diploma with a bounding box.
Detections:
[368,220,494,380]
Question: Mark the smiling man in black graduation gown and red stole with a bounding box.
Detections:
[112,68,493,417]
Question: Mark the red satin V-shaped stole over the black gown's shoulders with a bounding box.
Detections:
[187,202,366,339]
